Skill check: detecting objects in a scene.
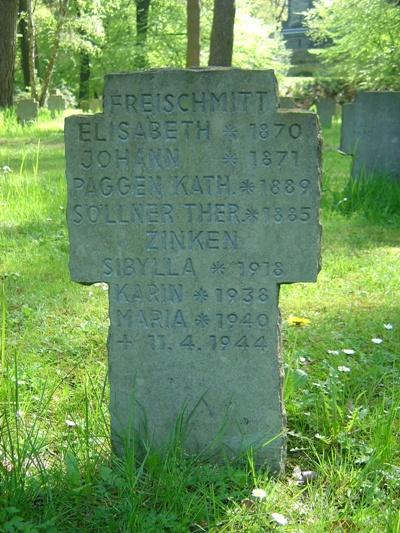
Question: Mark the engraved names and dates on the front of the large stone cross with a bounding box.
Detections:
[71,84,317,358]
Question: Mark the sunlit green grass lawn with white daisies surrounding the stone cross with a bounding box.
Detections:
[0,112,400,533]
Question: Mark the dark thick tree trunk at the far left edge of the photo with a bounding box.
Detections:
[0,0,18,107]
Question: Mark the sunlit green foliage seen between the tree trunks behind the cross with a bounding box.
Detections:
[17,0,289,101]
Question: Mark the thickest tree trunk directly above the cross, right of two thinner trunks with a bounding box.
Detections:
[208,0,235,67]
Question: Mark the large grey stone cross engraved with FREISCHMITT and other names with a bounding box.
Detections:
[65,69,320,471]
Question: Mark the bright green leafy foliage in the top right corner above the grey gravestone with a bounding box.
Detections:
[306,0,400,90]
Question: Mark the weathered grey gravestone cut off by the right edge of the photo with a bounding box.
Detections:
[352,92,400,180]
